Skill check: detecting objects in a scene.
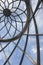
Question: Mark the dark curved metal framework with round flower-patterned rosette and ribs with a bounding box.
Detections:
[0,0,43,65]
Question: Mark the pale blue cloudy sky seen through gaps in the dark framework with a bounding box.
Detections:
[0,0,43,65]
